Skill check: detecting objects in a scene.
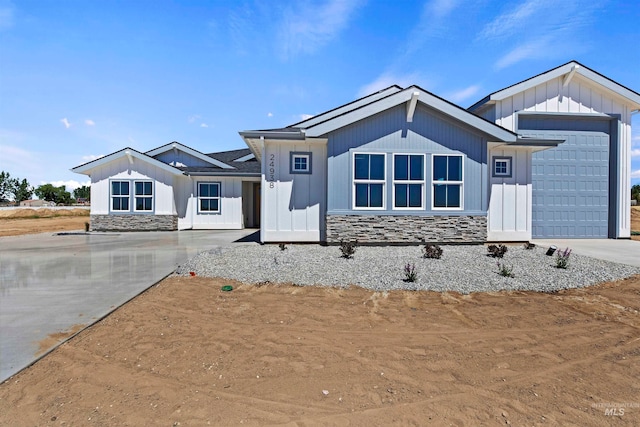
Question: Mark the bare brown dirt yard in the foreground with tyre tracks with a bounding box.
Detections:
[0,276,640,426]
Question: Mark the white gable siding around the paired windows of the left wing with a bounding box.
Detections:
[91,157,176,215]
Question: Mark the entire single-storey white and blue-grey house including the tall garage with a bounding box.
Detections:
[73,61,640,244]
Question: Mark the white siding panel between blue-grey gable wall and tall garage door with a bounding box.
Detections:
[487,144,533,241]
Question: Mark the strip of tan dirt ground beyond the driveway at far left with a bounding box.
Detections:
[0,208,89,237]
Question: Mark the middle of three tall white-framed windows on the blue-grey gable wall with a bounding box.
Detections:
[393,154,424,209]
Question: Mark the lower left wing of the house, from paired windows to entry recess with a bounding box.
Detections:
[72,142,260,231]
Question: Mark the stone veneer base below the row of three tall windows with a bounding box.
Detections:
[326,215,487,244]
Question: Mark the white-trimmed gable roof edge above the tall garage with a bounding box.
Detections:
[468,61,640,111]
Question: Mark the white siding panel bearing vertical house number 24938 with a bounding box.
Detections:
[260,140,327,242]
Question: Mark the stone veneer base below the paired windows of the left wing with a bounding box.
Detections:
[90,215,178,231]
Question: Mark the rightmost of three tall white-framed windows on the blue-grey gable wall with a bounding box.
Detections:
[433,154,463,209]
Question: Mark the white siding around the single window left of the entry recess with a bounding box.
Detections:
[174,176,258,230]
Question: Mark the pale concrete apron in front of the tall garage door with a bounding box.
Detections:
[532,239,640,267]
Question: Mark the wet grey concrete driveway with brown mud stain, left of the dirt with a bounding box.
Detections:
[0,230,256,382]
